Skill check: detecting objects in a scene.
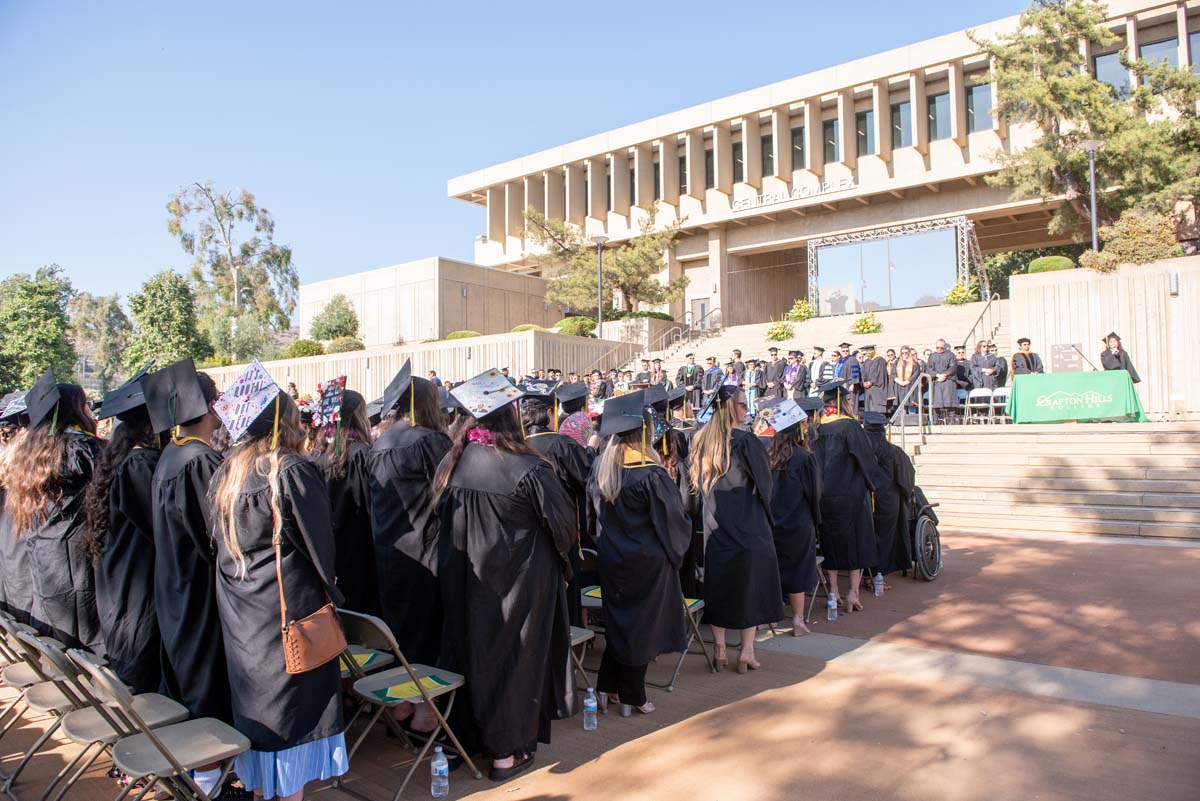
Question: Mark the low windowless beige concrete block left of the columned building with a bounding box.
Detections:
[300,257,563,348]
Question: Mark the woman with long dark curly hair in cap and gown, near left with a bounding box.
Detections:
[85,366,162,693]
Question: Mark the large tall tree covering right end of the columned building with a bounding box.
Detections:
[971,0,1200,244]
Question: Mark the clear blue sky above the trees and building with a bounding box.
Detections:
[0,0,1027,295]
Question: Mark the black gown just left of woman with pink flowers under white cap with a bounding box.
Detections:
[370,422,450,664]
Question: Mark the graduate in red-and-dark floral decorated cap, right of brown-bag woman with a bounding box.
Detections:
[311,377,382,616]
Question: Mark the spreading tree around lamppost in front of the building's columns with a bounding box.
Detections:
[526,209,688,311]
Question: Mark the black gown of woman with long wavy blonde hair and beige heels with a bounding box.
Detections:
[703,429,784,628]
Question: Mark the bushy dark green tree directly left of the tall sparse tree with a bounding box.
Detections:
[125,270,212,369]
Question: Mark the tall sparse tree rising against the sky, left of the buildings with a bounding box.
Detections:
[167,182,300,356]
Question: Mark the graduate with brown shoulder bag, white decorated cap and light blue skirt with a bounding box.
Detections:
[210,361,349,801]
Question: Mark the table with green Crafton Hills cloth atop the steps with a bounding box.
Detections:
[1007,369,1150,423]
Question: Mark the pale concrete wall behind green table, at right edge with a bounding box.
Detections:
[1009,257,1200,415]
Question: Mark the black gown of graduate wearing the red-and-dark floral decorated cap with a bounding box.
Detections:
[323,439,380,616]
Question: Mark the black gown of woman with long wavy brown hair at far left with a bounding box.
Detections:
[22,433,104,655]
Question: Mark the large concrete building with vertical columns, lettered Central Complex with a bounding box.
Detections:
[448,0,1200,325]
